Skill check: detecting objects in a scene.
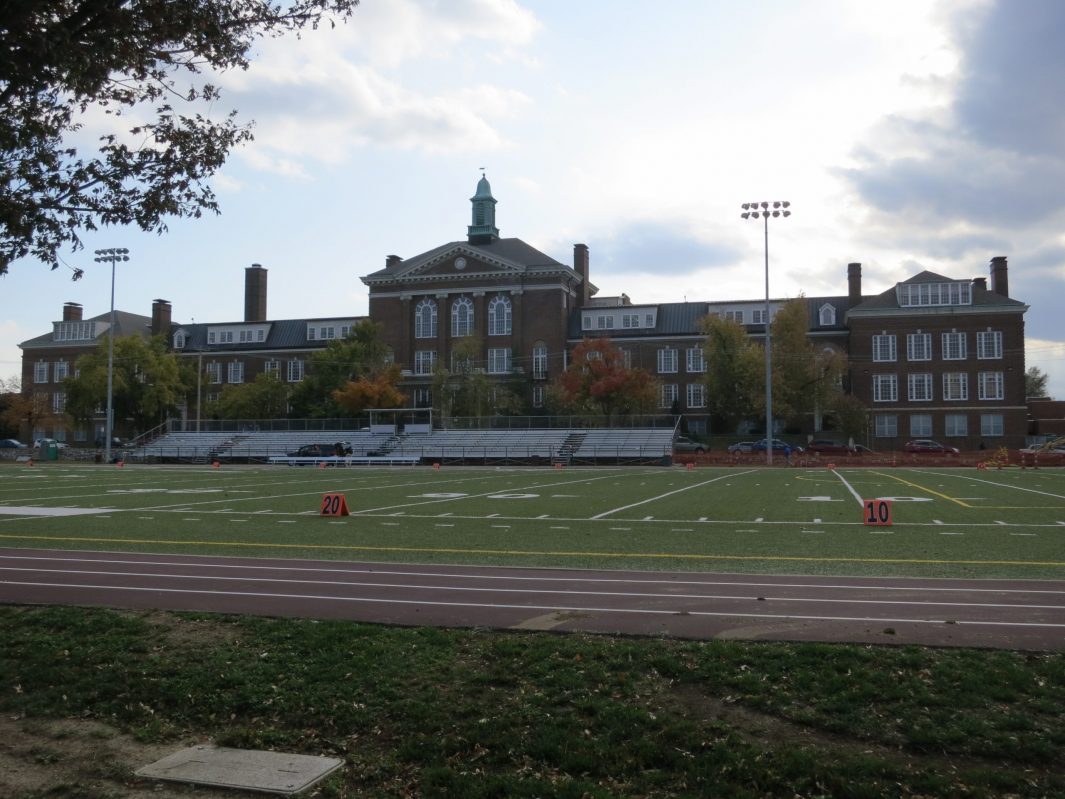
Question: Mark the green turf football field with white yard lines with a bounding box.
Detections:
[0,464,1065,580]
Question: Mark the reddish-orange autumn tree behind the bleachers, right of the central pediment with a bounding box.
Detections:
[551,339,659,424]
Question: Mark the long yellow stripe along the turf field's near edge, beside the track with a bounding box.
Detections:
[0,535,1065,567]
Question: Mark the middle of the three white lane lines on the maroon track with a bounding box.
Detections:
[0,567,1065,613]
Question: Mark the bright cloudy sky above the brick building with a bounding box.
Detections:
[0,0,1065,398]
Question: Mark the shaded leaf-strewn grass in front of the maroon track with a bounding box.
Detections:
[0,607,1065,799]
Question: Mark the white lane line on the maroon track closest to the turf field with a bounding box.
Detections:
[0,558,1065,596]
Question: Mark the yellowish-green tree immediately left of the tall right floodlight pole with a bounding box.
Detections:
[702,316,766,430]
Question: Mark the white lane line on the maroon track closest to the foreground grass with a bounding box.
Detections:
[4,582,1065,629]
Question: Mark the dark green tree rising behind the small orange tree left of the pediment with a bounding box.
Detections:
[291,320,391,419]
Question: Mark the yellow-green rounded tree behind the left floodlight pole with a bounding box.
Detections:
[63,336,190,431]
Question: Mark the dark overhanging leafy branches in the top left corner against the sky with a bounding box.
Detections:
[0,0,358,279]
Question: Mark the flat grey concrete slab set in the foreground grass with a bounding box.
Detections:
[135,745,343,796]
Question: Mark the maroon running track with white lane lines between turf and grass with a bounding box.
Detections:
[0,549,1065,651]
